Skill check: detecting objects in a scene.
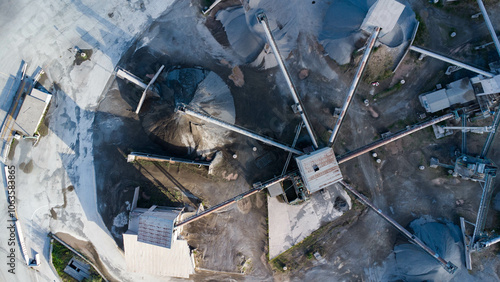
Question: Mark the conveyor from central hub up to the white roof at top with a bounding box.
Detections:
[328,27,381,147]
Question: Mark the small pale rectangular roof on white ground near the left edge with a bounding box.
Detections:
[14,89,52,136]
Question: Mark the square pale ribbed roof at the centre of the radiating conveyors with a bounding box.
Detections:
[295,147,342,193]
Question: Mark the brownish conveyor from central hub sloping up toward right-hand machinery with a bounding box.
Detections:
[337,113,455,164]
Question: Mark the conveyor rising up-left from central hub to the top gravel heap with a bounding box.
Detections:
[257,12,318,148]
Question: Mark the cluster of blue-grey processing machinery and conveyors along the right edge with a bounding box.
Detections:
[410,0,500,270]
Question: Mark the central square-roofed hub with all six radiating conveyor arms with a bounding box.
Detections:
[171,12,457,273]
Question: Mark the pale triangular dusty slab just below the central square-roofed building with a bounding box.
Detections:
[267,185,351,259]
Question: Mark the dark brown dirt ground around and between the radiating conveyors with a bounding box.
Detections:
[94,1,500,281]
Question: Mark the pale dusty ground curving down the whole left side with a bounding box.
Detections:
[0,0,180,281]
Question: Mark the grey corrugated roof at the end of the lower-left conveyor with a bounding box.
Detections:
[137,207,180,248]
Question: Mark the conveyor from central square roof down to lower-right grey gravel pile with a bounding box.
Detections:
[340,180,457,273]
